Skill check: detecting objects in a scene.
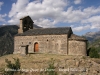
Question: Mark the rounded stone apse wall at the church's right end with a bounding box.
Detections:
[68,40,86,56]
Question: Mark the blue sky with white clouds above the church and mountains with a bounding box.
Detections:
[0,0,100,35]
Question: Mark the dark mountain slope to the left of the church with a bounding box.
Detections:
[0,25,19,56]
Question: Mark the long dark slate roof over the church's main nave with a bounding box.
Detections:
[16,27,73,36]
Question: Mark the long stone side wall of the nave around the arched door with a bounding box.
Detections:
[14,35,68,54]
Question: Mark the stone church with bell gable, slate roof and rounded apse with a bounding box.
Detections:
[14,16,87,56]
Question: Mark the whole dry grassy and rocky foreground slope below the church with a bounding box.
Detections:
[0,54,100,75]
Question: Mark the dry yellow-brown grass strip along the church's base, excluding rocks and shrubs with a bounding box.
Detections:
[0,54,100,74]
